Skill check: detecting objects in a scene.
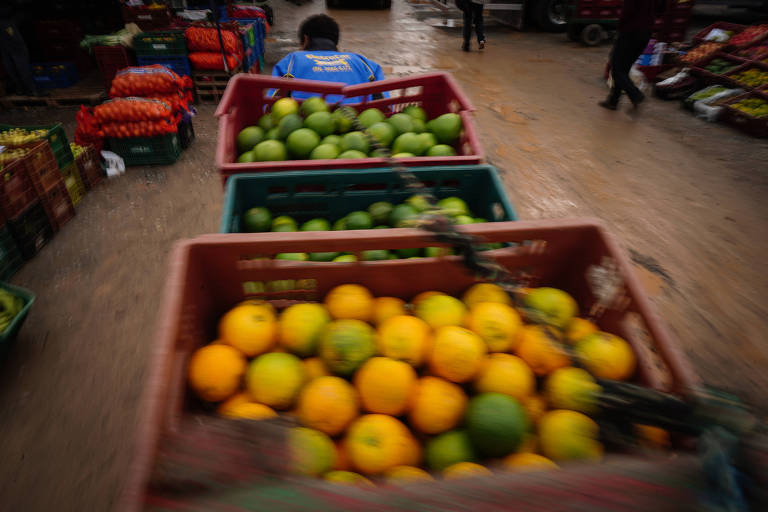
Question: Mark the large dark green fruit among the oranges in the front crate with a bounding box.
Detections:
[464,393,530,457]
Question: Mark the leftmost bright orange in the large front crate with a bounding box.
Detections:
[188,345,246,402]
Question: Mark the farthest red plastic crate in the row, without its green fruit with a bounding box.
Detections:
[215,73,484,182]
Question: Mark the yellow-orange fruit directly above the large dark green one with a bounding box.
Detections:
[475,354,536,402]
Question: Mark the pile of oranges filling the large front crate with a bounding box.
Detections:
[188,283,635,485]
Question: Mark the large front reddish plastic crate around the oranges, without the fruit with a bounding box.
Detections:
[122,219,699,510]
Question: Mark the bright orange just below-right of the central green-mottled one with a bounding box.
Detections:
[355,357,416,416]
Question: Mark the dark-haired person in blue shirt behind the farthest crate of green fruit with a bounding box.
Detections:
[272,14,384,103]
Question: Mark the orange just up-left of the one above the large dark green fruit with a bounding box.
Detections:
[429,325,486,382]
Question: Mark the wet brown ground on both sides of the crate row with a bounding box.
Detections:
[0,0,768,511]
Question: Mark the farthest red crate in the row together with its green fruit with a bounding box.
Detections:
[216,73,483,181]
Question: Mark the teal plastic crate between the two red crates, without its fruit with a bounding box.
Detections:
[220,165,517,233]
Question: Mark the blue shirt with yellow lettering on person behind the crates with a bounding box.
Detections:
[271,50,388,103]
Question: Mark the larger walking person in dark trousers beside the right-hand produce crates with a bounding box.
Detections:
[598,0,664,110]
